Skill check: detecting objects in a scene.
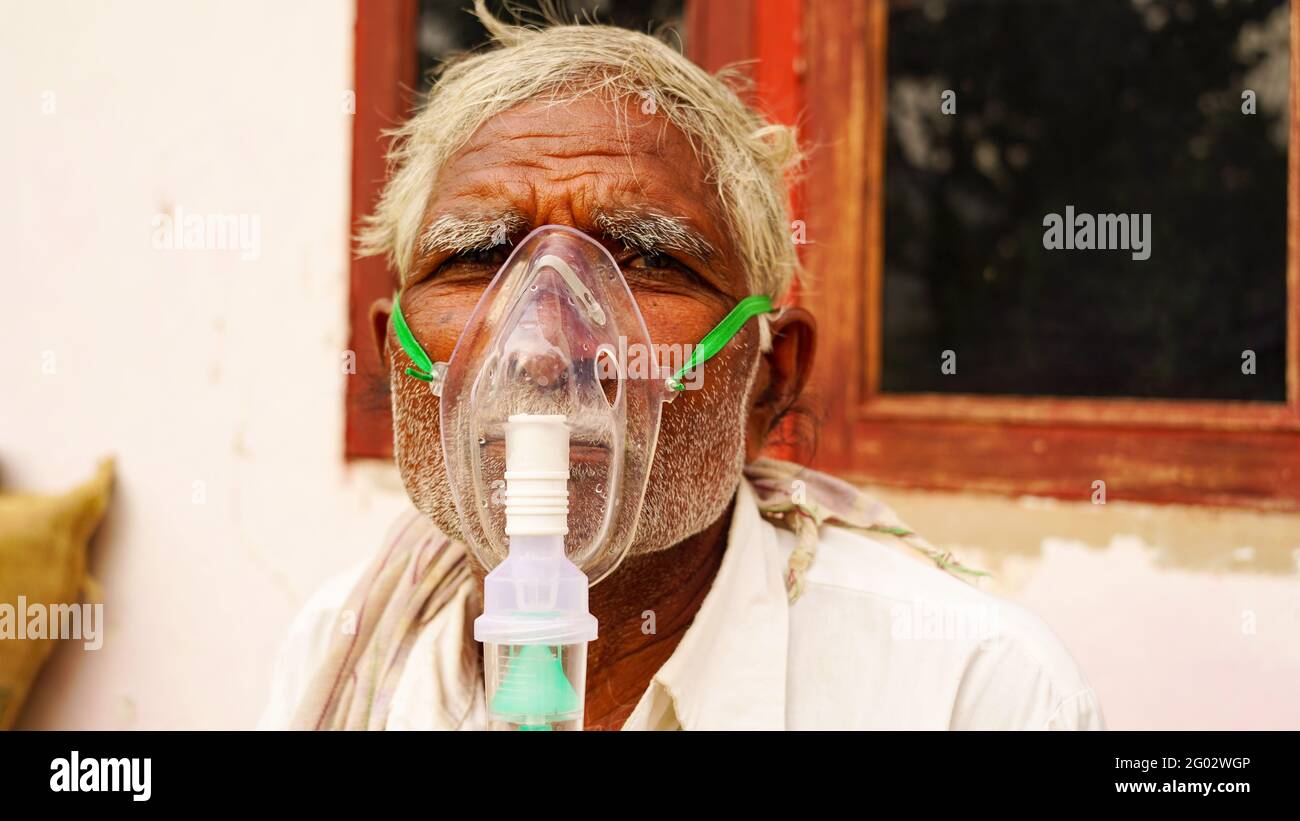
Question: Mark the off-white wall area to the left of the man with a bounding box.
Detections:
[0,0,404,729]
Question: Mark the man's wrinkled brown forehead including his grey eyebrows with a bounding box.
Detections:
[412,95,744,295]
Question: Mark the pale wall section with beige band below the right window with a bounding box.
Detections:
[872,486,1300,730]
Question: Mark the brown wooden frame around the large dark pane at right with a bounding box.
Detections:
[802,0,1300,511]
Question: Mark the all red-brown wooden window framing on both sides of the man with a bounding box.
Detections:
[347,0,1300,509]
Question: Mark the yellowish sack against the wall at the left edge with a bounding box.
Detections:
[0,460,113,730]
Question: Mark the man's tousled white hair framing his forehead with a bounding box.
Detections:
[359,0,801,297]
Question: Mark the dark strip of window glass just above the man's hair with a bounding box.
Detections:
[416,0,685,91]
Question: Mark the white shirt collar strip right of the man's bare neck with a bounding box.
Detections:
[624,481,789,730]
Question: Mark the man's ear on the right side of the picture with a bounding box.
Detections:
[745,307,816,461]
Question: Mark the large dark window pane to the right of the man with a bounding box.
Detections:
[883,0,1290,400]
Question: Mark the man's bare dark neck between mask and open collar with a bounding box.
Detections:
[476,500,736,730]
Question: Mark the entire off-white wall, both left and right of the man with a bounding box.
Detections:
[0,0,1300,729]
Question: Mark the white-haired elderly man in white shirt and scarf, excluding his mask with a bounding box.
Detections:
[263,1,1101,729]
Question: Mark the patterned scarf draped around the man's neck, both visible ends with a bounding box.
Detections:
[293,459,984,730]
